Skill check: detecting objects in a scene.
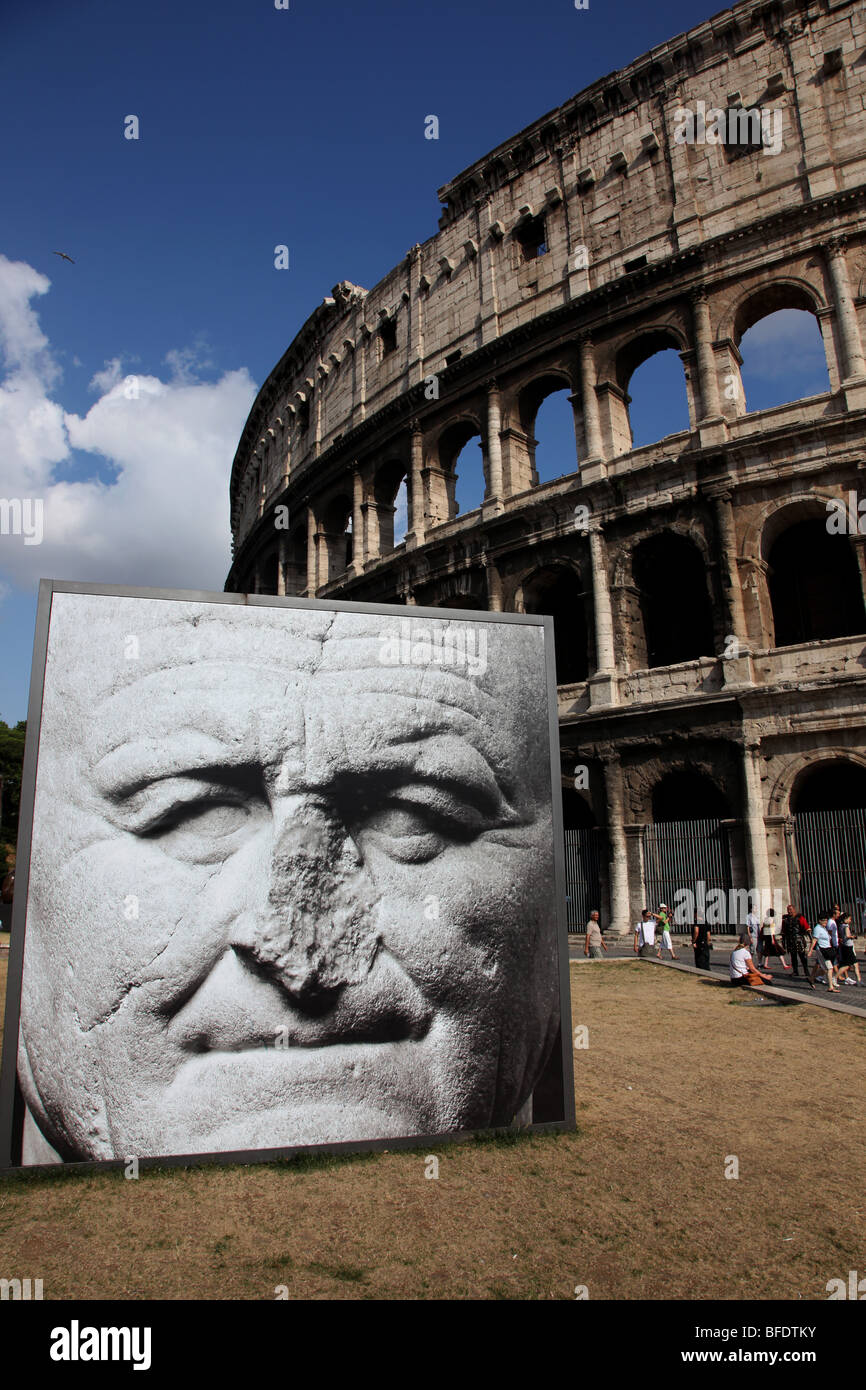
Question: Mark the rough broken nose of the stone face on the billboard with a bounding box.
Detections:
[231,803,379,1012]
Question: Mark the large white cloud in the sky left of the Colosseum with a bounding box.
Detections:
[0,256,256,589]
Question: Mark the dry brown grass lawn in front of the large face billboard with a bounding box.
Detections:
[0,962,866,1300]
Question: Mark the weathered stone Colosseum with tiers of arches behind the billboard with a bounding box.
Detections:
[225,0,866,933]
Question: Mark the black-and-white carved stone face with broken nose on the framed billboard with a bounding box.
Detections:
[19,594,559,1162]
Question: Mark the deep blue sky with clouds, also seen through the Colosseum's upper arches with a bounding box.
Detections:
[0,0,823,723]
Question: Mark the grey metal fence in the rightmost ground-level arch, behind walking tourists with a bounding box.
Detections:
[792,809,866,931]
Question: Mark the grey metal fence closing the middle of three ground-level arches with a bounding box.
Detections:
[641,820,731,933]
